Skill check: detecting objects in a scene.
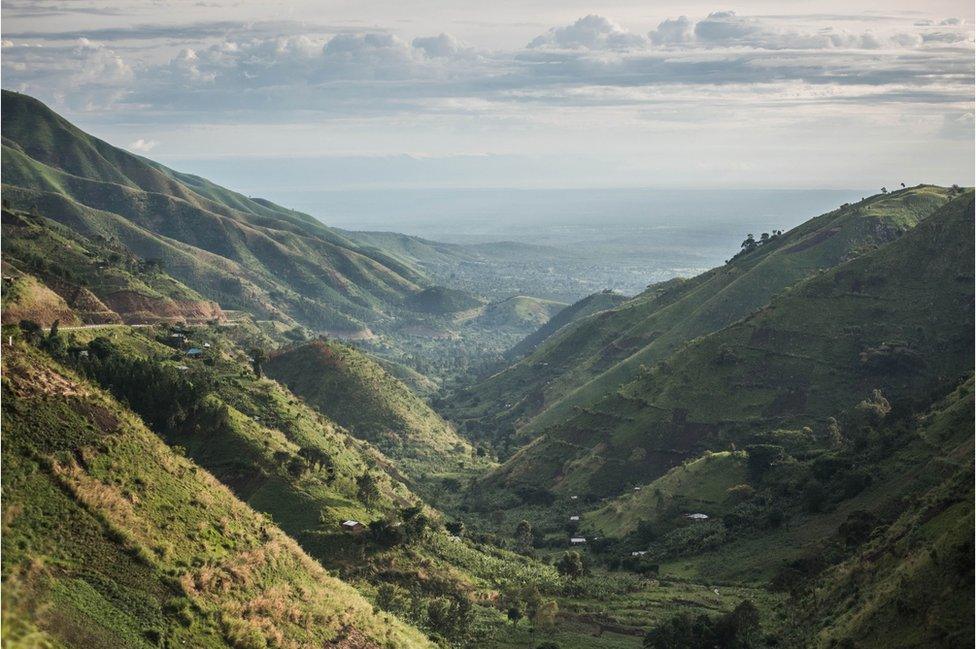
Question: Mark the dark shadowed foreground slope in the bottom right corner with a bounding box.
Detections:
[801,380,974,649]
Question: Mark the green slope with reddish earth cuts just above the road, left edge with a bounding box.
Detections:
[3,210,223,324]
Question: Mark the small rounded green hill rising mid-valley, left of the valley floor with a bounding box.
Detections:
[267,339,482,482]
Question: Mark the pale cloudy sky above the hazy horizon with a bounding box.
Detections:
[0,0,974,191]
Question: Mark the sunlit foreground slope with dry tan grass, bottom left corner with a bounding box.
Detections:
[3,343,430,647]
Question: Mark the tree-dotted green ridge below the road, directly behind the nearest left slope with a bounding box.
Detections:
[42,325,572,639]
